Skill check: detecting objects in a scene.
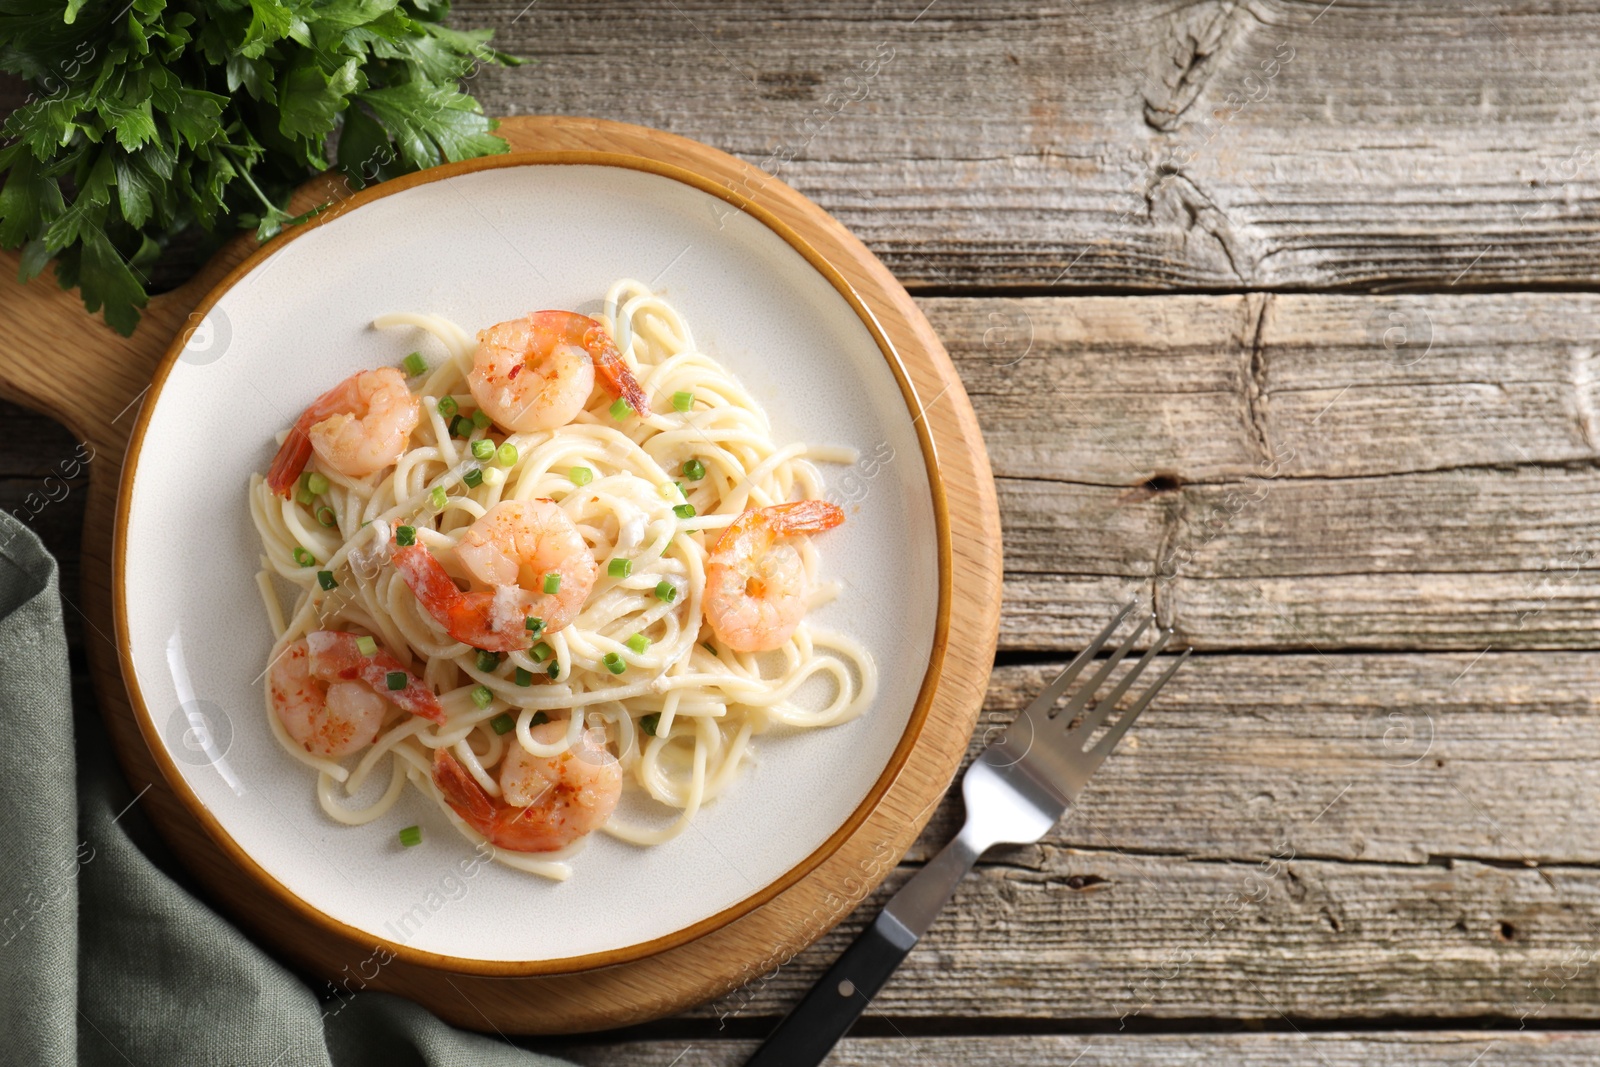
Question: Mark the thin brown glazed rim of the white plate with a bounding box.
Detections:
[110,149,954,977]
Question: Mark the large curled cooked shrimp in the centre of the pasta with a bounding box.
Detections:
[394,499,600,653]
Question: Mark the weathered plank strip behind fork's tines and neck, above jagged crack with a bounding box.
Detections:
[910,653,1600,867]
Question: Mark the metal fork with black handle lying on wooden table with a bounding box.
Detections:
[749,601,1190,1067]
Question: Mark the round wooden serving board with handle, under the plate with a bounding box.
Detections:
[0,117,1000,1033]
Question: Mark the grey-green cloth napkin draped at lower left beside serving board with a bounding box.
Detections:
[0,512,576,1067]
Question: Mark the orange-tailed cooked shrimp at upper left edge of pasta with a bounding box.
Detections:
[267,366,419,498]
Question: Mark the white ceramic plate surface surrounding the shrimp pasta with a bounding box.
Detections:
[120,162,939,969]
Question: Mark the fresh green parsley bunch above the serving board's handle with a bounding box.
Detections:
[0,0,517,334]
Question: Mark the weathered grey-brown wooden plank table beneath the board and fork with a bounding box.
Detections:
[12,0,1600,1067]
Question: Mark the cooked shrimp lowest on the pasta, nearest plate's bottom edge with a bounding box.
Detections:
[434,720,622,853]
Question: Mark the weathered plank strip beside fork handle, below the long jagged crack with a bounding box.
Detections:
[649,844,1600,1021]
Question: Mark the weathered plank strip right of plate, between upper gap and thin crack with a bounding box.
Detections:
[922,293,1600,486]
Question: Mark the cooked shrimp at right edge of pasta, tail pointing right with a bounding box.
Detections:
[706,501,845,653]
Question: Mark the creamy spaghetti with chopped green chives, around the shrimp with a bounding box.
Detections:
[250,280,877,878]
